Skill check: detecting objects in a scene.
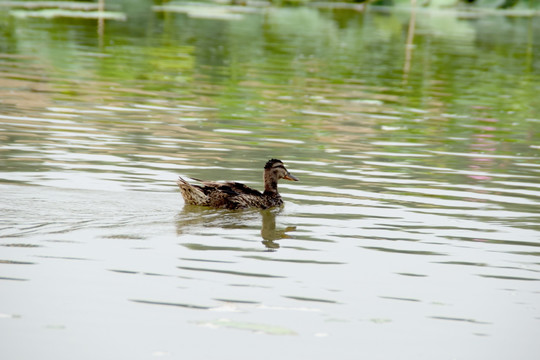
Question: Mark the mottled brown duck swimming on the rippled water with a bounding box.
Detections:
[176,159,299,210]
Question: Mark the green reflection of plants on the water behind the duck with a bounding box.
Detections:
[0,6,540,194]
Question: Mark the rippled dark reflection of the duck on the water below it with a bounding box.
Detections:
[176,205,296,251]
